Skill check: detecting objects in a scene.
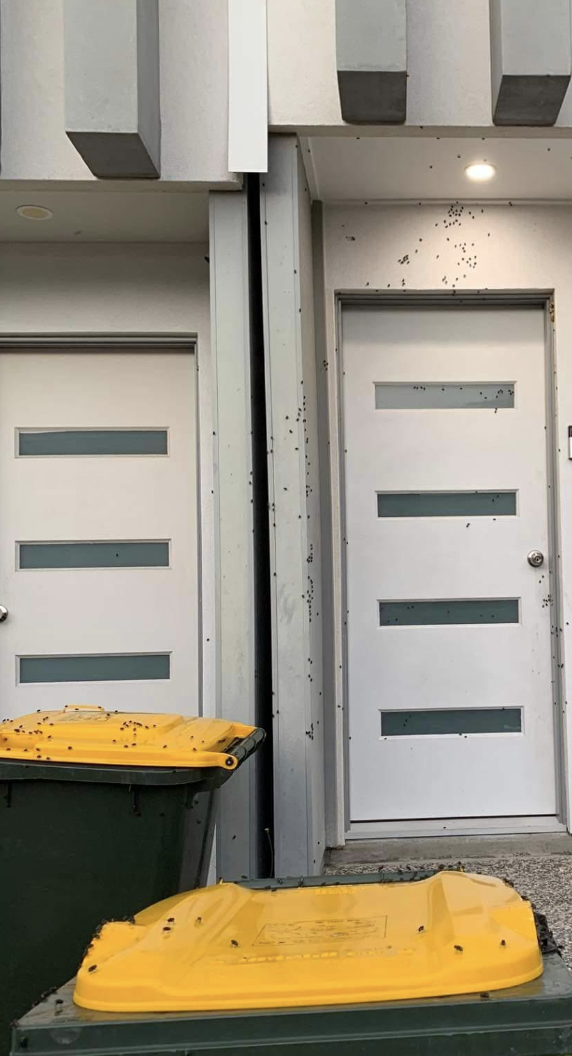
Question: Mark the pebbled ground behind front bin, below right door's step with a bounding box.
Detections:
[325,854,572,967]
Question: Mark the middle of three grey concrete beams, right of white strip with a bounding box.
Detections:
[336,0,407,125]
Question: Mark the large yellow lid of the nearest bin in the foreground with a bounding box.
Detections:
[74,871,542,1012]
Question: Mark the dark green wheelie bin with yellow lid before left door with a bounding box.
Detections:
[0,705,264,1056]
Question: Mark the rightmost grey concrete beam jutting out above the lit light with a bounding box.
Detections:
[491,0,572,126]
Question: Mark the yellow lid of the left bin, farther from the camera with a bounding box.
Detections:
[0,704,255,770]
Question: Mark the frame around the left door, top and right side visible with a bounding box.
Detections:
[0,331,208,715]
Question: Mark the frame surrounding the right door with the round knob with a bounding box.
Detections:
[324,289,568,847]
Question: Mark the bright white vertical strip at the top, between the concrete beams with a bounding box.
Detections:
[228,0,268,172]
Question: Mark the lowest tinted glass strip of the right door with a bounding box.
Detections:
[381,708,522,737]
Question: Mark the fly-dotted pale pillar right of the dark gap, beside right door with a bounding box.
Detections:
[261,136,324,875]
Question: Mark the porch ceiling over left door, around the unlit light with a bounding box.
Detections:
[0,184,209,242]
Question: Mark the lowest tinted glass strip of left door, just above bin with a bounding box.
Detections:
[20,653,171,682]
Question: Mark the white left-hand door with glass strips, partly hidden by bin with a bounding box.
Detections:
[0,351,198,718]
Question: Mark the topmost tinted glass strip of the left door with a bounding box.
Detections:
[18,429,168,455]
